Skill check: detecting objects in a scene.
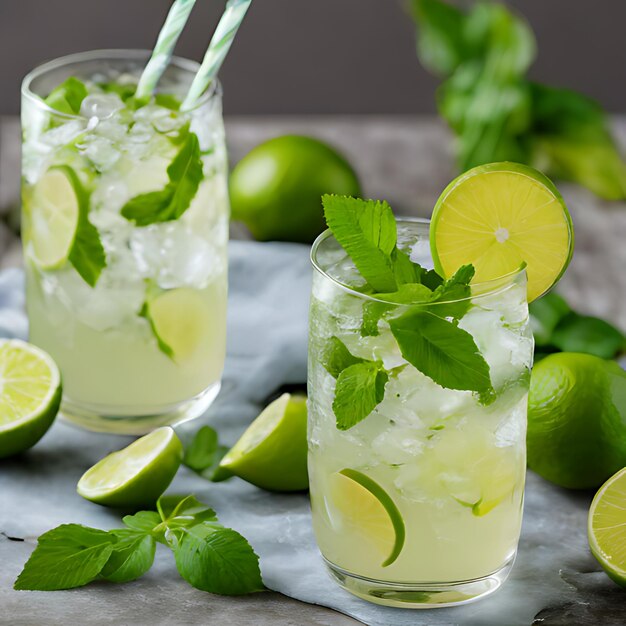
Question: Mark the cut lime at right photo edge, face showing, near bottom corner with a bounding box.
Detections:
[587,467,626,587]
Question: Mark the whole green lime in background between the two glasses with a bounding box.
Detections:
[230,135,361,243]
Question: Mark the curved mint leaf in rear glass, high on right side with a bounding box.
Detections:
[121,133,204,226]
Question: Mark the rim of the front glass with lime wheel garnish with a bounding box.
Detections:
[309,216,526,307]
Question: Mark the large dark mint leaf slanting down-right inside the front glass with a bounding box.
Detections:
[389,309,493,394]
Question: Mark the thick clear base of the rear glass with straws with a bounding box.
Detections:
[59,381,220,435]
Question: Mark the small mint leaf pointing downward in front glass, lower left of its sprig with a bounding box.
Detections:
[333,361,389,430]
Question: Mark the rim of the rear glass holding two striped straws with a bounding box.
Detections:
[20,48,222,120]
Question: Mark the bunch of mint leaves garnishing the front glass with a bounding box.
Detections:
[321,195,494,430]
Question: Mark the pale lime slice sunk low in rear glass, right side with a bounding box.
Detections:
[146,287,211,361]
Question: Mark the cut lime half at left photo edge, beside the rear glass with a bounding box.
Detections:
[0,339,61,458]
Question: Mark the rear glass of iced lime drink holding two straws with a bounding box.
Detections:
[22,50,229,433]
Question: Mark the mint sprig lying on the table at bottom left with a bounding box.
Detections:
[14,495,265,595]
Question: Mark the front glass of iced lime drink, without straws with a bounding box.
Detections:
[308,220,533,607]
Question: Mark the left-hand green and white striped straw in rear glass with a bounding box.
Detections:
[135,0,196,103]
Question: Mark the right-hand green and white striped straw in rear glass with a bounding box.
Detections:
[180,0,252,111]
